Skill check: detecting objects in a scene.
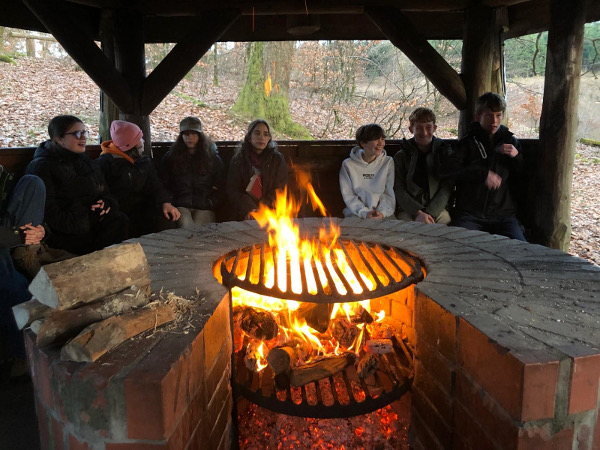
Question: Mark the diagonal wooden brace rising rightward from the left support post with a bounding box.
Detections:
[141,10,239,114]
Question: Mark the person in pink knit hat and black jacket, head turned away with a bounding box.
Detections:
[97,120,181,237]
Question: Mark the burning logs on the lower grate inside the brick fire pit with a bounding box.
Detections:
[233,303,401,387]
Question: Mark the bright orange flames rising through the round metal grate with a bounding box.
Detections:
[231,172,385,372]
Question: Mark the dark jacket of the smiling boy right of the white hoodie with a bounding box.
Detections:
[394,137,454,218]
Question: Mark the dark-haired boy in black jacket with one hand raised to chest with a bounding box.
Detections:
[444,92,525,241]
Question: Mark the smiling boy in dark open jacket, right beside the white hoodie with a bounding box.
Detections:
[394,108,453,225]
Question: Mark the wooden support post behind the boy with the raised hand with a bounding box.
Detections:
[458,4,504,137]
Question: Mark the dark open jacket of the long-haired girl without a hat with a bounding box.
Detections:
[227,148,288,220]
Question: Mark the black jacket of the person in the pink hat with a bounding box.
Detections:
[95,153,171,214]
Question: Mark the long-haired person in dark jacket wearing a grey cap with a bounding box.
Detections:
[160,116,225,228]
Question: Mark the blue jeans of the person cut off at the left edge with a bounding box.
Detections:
[0,175,46,358]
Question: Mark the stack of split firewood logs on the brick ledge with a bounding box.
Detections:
[13,243,175,362]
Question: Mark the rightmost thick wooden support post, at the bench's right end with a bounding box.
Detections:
[533,0,586,251]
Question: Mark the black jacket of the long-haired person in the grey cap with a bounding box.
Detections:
[160,150,225,211]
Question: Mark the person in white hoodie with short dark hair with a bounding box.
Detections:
[340,123,396,219]
